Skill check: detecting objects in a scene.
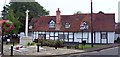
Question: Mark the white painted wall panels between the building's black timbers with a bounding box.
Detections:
[31,32,115,43]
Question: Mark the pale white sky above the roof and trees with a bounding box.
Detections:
[0,0,120,22]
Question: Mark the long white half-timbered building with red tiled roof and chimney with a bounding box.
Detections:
[29,9,115,43]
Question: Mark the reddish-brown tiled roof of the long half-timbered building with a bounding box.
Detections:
[31,13,115,32]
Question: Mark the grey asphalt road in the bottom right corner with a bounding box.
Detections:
[60,47,120,57]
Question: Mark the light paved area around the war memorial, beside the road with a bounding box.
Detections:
[0,44,120,57]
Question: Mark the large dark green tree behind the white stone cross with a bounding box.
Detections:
[3,2,49,32]
